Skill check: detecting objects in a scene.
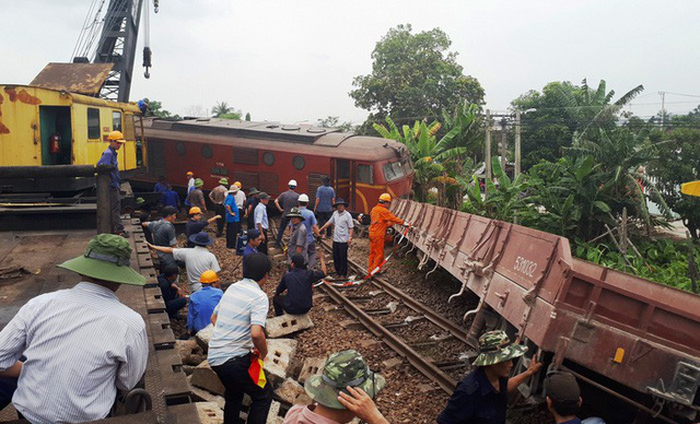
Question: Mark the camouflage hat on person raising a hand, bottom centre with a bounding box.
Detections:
[304,349,386,409]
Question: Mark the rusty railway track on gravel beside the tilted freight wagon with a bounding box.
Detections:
[320,238,473,394]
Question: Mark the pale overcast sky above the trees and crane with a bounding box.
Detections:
[0,0,700,123]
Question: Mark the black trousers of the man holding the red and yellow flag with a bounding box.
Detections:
[211,354,272,424]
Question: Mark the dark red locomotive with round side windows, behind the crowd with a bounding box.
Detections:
[140,118,414,213]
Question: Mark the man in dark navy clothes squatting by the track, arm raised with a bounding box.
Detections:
[272,252,327,316]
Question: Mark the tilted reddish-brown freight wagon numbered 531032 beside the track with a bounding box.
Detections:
[391,199,700,422]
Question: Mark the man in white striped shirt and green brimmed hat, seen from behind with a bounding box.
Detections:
[0,234,148,424]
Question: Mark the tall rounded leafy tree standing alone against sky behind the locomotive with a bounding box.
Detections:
[350,25,484,128]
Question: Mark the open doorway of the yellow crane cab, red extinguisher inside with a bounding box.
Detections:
[39,106,73,165]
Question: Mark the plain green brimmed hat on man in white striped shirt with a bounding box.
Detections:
[58,234,146,286]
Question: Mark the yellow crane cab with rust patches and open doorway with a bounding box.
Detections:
[0,64,146,193]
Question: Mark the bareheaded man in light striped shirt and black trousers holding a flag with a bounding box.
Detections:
[208,253,272,424]
